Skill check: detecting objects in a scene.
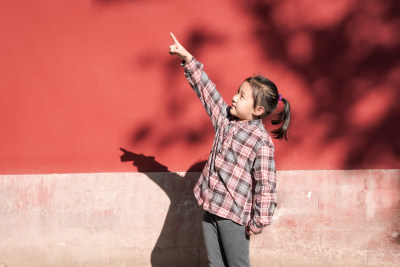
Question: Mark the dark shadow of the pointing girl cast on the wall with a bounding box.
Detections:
[120,148,207,266]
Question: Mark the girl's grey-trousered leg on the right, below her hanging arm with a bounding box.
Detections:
[217,218,250,267]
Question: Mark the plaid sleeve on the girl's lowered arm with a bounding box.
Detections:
[247,144,277,234]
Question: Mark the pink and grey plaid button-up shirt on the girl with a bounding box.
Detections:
[182,58,277,233]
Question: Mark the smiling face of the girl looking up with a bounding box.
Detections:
[230,81,256,121]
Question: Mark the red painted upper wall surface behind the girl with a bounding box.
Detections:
[0,0,400,174]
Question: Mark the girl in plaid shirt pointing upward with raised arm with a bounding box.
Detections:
[169,33,290,266]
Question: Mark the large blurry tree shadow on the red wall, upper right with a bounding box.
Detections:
[240,0,400,168]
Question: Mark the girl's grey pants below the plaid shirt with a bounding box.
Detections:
[202,211,250,267]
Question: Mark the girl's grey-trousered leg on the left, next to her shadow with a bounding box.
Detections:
[202,212,228,267]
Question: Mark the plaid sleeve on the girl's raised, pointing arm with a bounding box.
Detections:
[181,58,228,128]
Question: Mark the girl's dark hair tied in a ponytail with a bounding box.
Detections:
[245,76,290,140]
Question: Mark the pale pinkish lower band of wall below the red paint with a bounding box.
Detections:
[0,170,400,266]
